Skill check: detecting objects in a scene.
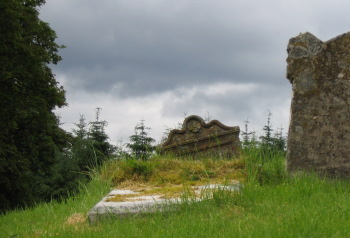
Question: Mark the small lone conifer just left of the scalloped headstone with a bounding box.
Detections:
[127,120,155,160]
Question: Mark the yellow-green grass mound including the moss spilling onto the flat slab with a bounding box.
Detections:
[98,156,245,202]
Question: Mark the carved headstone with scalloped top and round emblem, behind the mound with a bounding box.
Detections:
[162,115,240,156]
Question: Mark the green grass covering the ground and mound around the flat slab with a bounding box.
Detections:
[0,150,350,237]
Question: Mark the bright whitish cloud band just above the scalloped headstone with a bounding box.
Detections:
[162,80,291,122]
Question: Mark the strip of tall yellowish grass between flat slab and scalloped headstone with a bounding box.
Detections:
[98,156,245,187]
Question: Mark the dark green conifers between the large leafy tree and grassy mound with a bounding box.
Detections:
[46,108,115,199]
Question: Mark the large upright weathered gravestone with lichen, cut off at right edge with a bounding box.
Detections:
[287,32,350,177]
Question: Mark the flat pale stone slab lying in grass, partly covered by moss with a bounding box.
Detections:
[88,182,242,224]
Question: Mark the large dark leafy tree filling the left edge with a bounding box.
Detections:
[0,0,68,211]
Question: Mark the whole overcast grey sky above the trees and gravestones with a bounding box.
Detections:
[40,0,350,143]
